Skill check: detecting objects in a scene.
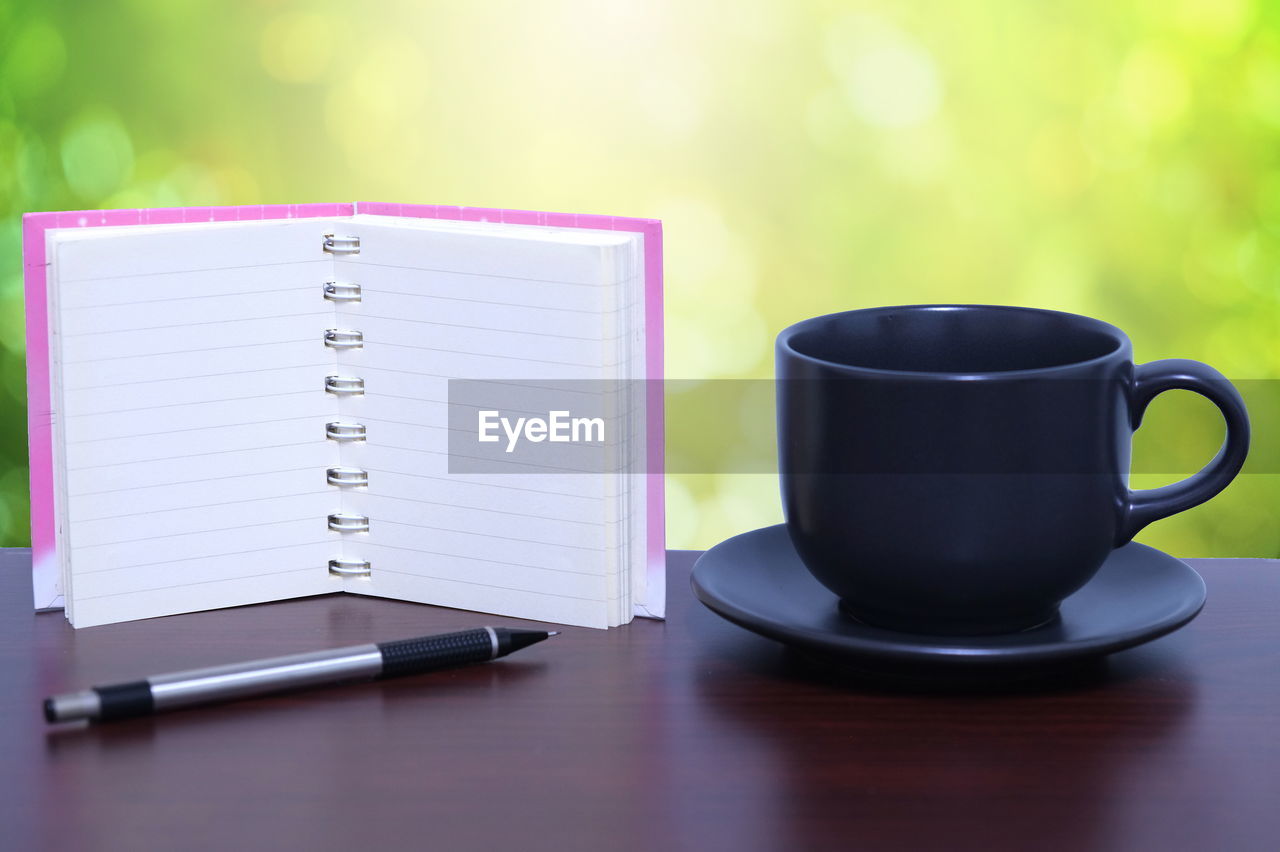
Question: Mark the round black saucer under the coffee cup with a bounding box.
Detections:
[692,525,1204,670]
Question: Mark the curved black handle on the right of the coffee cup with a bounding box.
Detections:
[1116,358,1249,546]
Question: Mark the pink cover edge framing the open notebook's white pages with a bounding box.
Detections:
[22,201,666,609]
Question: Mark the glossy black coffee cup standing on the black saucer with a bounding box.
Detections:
[777,304,1249,635]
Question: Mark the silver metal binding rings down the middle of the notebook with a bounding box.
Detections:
[321,233,372,578]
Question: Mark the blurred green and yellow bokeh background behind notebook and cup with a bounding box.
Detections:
[0,0,1280,556]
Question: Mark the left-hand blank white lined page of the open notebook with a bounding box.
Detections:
[50,219,340,627]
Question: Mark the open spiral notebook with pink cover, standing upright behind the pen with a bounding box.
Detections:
[24,203,664,627]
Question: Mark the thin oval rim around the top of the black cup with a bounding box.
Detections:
[777,303,1133,381]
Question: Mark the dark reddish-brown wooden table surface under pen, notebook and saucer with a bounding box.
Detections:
[0,550,1280,852]
